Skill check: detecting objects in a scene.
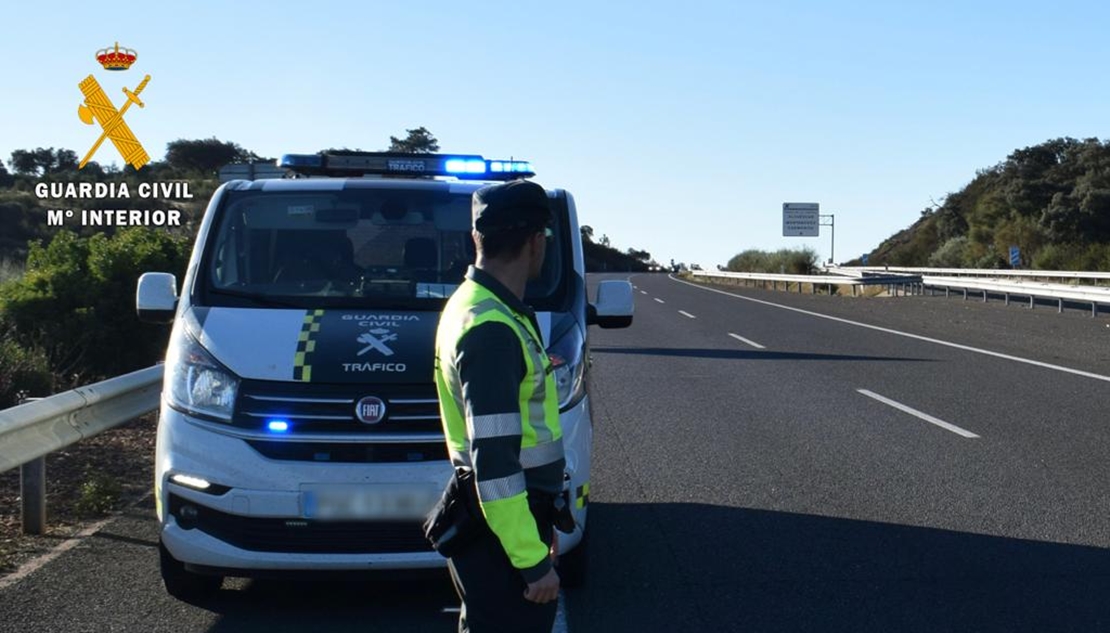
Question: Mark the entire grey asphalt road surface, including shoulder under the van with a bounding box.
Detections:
[0,275,1110,633]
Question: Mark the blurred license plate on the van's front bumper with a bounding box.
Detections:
[301,485,440,521]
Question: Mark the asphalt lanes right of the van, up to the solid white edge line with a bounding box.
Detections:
[568,275,1110,631]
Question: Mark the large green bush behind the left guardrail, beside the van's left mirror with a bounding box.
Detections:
[0,228,189,388]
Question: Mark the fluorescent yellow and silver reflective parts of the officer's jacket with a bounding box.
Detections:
[435,279,565,570]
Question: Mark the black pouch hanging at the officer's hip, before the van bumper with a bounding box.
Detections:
[424,468,490,559]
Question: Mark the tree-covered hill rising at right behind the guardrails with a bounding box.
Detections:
[849,138,1110,271]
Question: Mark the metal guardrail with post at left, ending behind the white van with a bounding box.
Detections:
[0,365,162,534]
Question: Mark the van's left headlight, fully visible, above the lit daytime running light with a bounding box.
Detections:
[163,328,239,422]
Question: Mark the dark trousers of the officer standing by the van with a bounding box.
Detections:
[447,497,557,633]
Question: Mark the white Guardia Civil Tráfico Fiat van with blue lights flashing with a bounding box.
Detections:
[137,152,633,599]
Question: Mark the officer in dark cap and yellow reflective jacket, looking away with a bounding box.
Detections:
[435,180,565,633]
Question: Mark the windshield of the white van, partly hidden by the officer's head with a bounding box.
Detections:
[198,183,571,310]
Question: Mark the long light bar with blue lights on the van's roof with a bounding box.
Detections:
[278,152,536,180]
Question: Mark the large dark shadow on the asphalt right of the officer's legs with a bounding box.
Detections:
[567,503,1110,633]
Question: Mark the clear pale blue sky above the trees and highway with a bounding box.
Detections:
[0,0,1110,268]
